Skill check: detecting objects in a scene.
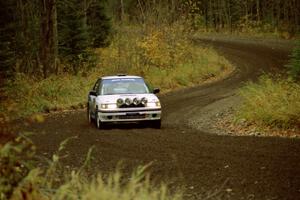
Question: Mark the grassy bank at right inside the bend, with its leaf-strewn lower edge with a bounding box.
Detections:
[234,76,300,137]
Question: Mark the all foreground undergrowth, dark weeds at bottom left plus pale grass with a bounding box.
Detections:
[0,136,182,200]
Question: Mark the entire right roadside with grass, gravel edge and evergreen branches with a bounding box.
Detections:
[217,41,300,137]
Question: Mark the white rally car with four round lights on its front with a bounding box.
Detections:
[87,75,161,129]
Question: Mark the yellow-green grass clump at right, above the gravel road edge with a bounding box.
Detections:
[236,76,300,128]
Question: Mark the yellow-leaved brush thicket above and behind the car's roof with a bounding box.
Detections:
[96,23,229,76]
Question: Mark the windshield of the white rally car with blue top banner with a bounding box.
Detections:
[100,78,149,95]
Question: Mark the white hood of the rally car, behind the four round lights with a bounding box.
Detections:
[97,94,158,104]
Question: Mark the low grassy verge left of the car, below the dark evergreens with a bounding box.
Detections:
[0,74,95,119]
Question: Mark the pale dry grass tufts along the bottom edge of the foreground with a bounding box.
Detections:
[12,167,182,200]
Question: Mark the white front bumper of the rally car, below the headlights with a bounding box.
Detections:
[98,109,161,122]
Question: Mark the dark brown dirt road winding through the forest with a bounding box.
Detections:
[23,39,300,200]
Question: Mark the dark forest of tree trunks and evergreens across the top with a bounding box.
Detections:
[0,0,300,78]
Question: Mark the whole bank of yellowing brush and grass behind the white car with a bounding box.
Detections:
[0,24,231,119]
